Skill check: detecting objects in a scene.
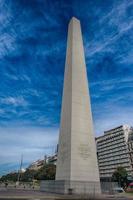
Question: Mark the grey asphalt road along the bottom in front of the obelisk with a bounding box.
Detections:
[0,188,133,200]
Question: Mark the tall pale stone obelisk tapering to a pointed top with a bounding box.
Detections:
[56,17,100,193]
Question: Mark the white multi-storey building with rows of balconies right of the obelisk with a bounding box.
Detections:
[96,125,133,179]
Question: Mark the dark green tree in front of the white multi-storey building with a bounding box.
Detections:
[112,167,128,188]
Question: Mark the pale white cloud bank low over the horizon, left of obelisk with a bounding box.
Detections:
[0,127,58,165]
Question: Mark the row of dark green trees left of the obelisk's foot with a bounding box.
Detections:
[0,164,56,182]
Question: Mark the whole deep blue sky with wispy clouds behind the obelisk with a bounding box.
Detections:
[0,0,133,174]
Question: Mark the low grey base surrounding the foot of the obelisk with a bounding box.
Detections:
[40,180,101,196]
